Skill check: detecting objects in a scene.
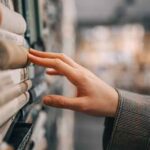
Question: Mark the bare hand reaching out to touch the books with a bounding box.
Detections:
[28,50,118,117]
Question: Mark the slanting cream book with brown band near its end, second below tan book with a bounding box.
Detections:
[0,80,32,106]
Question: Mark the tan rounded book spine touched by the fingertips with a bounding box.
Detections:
[0,40,28,70]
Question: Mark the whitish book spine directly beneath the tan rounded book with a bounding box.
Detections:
[0,68,29,90]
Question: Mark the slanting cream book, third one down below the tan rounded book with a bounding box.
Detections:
[0,92,29,126]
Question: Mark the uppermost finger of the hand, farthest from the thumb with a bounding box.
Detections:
[30,49,77,67]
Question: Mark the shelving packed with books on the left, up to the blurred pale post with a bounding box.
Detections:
[0,0,62,150]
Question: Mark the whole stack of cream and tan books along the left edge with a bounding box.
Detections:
[0,0,32,149]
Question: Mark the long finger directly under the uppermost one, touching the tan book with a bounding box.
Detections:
[28,54,77,82]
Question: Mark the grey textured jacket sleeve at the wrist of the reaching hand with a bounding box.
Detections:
[106,90,150,150]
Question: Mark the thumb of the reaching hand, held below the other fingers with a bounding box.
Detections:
[43,95,82,111]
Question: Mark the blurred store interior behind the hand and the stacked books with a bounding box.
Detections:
[0,0,150,150]
